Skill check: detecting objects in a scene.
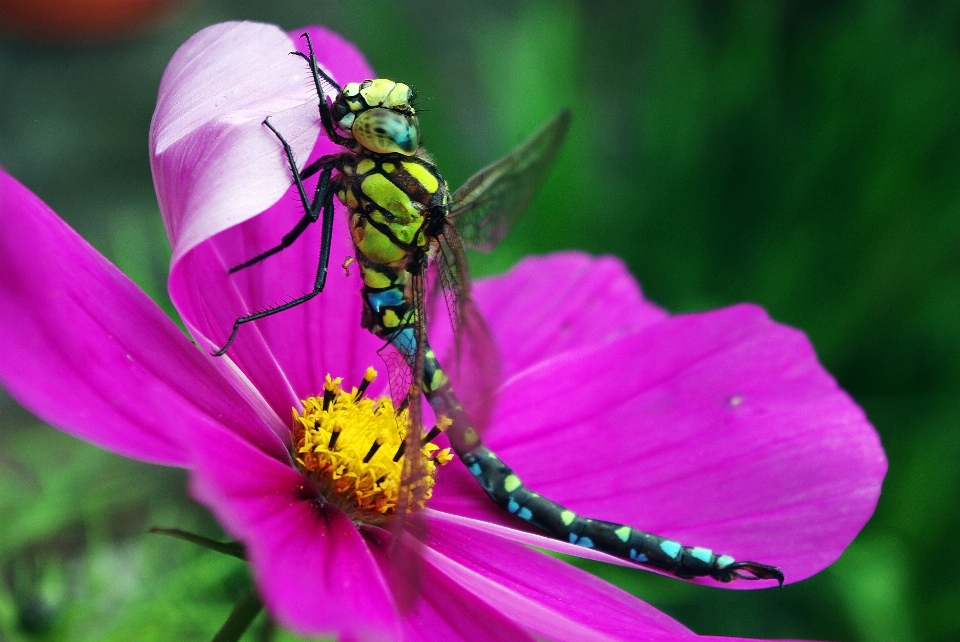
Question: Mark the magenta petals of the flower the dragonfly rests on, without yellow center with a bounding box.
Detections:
[0,23,886,640]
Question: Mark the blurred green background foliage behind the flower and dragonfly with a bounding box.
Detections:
[0,0,960,642]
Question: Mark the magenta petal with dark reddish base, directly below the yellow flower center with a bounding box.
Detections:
[191,422,399,640]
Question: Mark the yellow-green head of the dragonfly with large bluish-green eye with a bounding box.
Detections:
[330,78,420,156]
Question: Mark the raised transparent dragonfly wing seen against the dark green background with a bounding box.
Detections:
[448,109,570,252]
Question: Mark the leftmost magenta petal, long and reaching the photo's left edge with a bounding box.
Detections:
[0,171,285,465]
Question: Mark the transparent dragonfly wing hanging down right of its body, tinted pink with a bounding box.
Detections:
[435,221,500,432]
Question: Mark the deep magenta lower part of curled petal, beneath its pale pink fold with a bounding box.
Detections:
[170,199,385,417]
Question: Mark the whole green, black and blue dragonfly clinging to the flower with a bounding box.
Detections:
[214,34,784,585]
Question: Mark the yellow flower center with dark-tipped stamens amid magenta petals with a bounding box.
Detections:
[292,368,452,524]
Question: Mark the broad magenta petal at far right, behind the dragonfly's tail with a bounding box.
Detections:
[431,305,886,588]
